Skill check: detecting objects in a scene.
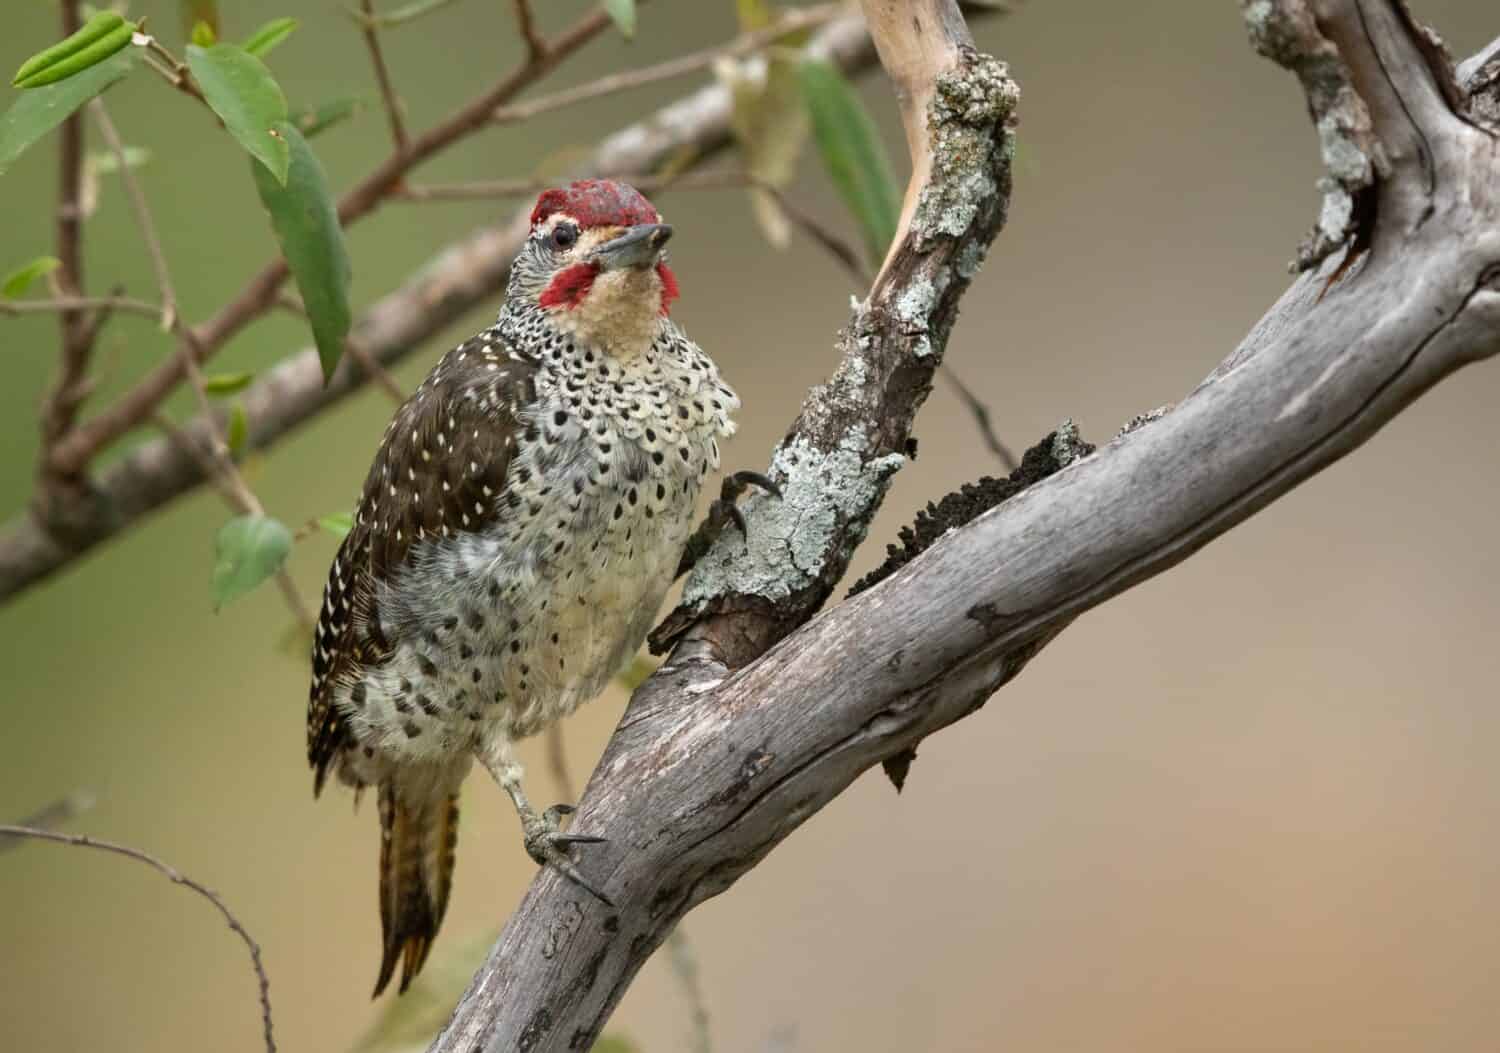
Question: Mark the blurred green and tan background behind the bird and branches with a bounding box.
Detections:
[0,0,1500,1053]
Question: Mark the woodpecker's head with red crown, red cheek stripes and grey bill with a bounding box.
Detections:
[512,179,677,359]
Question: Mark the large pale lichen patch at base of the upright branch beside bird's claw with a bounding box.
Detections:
[683,432,906,608]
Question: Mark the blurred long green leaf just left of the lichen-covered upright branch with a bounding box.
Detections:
[800,59,902,264]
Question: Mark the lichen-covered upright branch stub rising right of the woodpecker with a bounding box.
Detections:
[653,12,1017,668]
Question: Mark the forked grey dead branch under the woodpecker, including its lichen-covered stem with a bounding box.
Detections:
[434,0,1500,1053]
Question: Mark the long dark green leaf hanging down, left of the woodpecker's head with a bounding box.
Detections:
[252,122,350,381]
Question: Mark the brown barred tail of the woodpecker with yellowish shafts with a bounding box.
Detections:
[375,779,459,998]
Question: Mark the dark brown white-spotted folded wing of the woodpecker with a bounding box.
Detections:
[308,330,537,794]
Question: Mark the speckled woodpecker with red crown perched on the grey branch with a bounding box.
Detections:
[308,180,774,996]
